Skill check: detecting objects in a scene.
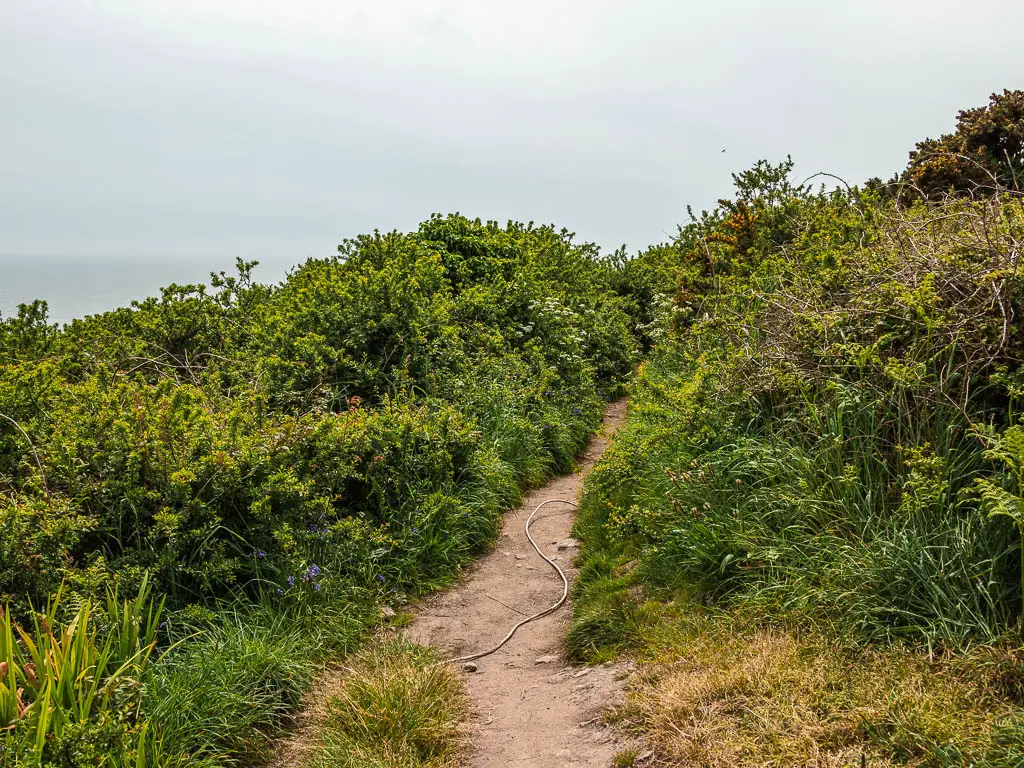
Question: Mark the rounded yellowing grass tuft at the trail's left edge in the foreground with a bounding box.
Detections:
[304,639,467,768]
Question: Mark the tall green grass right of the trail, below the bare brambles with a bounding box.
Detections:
[580,358,1020,645]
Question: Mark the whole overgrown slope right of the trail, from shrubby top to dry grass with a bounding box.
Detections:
[568,99,1024,766]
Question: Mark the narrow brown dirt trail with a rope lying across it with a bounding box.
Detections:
[406,401,626,768]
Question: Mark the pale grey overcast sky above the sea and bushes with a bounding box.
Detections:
[0,0,1024,268]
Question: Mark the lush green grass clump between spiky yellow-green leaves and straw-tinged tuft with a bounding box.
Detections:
[147,596,376,765]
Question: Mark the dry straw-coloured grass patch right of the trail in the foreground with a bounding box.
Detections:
[621,620,1019,768]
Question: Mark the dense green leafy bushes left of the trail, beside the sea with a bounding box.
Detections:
[0,216,635,604]
